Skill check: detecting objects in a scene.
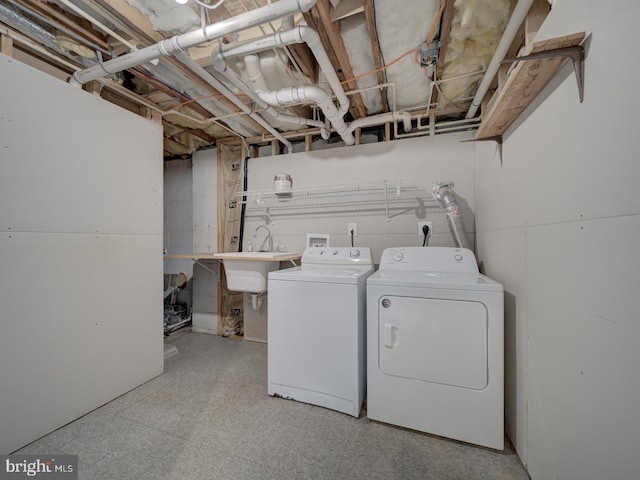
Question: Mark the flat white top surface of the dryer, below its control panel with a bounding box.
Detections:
[367,270,503,292]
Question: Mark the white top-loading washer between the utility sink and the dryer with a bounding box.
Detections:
[267,247,374,417]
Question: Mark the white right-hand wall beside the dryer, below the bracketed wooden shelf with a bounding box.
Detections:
[475,0,640,480]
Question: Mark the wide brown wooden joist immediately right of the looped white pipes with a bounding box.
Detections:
[304,0,367,119]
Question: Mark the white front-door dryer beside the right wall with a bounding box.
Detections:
[367,247,504,450]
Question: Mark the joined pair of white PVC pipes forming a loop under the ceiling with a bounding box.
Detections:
[211,26,355,145]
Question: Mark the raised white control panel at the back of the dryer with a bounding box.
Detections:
[380,247,479,273]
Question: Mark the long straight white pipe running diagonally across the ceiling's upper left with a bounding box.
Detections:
[69,0,316,86]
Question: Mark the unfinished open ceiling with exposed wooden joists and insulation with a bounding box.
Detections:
[0,0,549,158]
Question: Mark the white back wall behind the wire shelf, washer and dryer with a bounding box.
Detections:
[243,132,475,262]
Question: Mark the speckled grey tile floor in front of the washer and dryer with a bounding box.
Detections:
[16,331,528,480]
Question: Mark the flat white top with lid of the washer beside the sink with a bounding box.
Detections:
[269,265,374,284]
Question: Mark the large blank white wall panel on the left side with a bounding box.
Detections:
[0,54,163,454]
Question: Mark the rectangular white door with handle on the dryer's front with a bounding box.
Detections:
[378,295,488,390]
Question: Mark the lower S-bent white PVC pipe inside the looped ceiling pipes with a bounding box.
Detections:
[244,55,356,145]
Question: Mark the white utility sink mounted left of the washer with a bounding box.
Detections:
[213,252,302,293]
